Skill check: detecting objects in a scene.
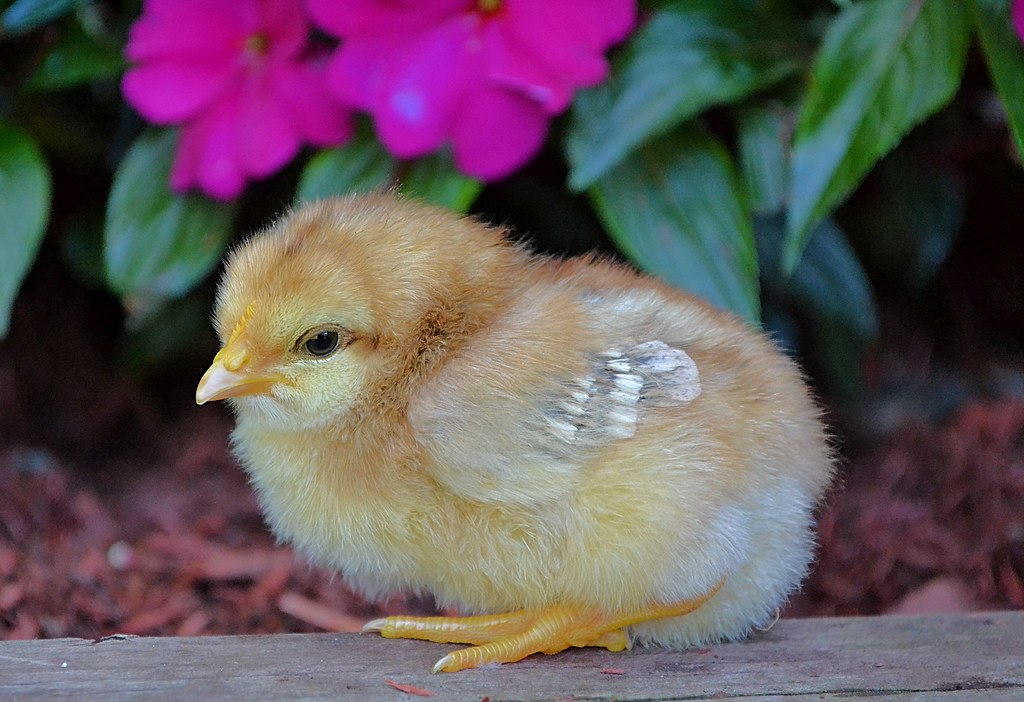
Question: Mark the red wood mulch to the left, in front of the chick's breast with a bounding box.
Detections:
[0,407,423,639]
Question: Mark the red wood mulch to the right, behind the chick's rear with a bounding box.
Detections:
[791,399,1024,615]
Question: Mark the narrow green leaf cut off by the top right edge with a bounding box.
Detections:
[974,0,1024,157]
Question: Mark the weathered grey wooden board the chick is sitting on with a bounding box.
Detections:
[0,612,1024,702]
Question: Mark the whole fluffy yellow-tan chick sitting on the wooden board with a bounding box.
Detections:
[196,194,833,671]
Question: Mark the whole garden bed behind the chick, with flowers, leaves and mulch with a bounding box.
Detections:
[0,0,1024,639]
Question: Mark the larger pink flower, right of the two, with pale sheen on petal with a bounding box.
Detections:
[309,0,636,179]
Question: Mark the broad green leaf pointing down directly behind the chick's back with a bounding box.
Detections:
[590,125,760,322]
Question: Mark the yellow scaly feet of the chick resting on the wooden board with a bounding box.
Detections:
[362,583,721,672]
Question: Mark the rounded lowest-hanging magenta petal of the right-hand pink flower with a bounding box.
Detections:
[452,88,548,180]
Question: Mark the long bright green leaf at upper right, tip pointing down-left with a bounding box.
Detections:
[782,0,971,270]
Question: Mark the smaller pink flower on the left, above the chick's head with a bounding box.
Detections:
[122,0,350,200]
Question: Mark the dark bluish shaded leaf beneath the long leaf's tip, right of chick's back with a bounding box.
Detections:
[754,214,879,343]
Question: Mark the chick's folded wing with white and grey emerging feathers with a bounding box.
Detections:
[410,286,700,506]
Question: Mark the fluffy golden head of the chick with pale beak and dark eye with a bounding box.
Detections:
[196,195,518,430]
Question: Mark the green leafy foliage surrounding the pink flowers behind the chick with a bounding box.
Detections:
[0,0,1024,405]
